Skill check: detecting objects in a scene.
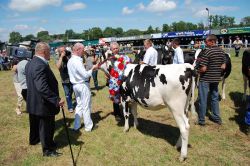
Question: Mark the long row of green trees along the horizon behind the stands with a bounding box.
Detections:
[9,15,250,44]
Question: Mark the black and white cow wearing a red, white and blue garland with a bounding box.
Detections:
[100,60,195,161]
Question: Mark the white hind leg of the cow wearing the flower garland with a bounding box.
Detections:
[170,105,190,161]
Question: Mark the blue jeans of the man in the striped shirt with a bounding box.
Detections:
[198,81,221,124]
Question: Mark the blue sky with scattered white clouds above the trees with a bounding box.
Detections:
[0,0,250,41]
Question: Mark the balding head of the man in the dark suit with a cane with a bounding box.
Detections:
[35,42,50,60]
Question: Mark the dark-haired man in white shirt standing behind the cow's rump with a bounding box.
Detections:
[172,38,184,64]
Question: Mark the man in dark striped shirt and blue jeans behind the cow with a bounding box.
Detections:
[198,35,226,126]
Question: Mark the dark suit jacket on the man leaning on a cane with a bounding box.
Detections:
[25,56,60,116]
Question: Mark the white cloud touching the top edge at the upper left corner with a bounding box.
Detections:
[8,0,62,12]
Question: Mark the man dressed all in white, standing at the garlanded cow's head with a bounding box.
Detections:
[67,43,98,131]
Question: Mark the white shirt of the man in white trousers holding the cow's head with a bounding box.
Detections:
[67,55,92,84]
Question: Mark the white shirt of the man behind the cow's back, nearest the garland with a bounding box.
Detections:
[143,47,158,66]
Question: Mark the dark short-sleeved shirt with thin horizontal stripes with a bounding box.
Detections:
[200,46,226,83]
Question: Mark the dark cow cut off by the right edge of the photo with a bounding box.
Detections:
[242,49,250,101]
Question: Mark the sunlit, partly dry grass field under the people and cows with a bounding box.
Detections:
[0,49,250,166]
